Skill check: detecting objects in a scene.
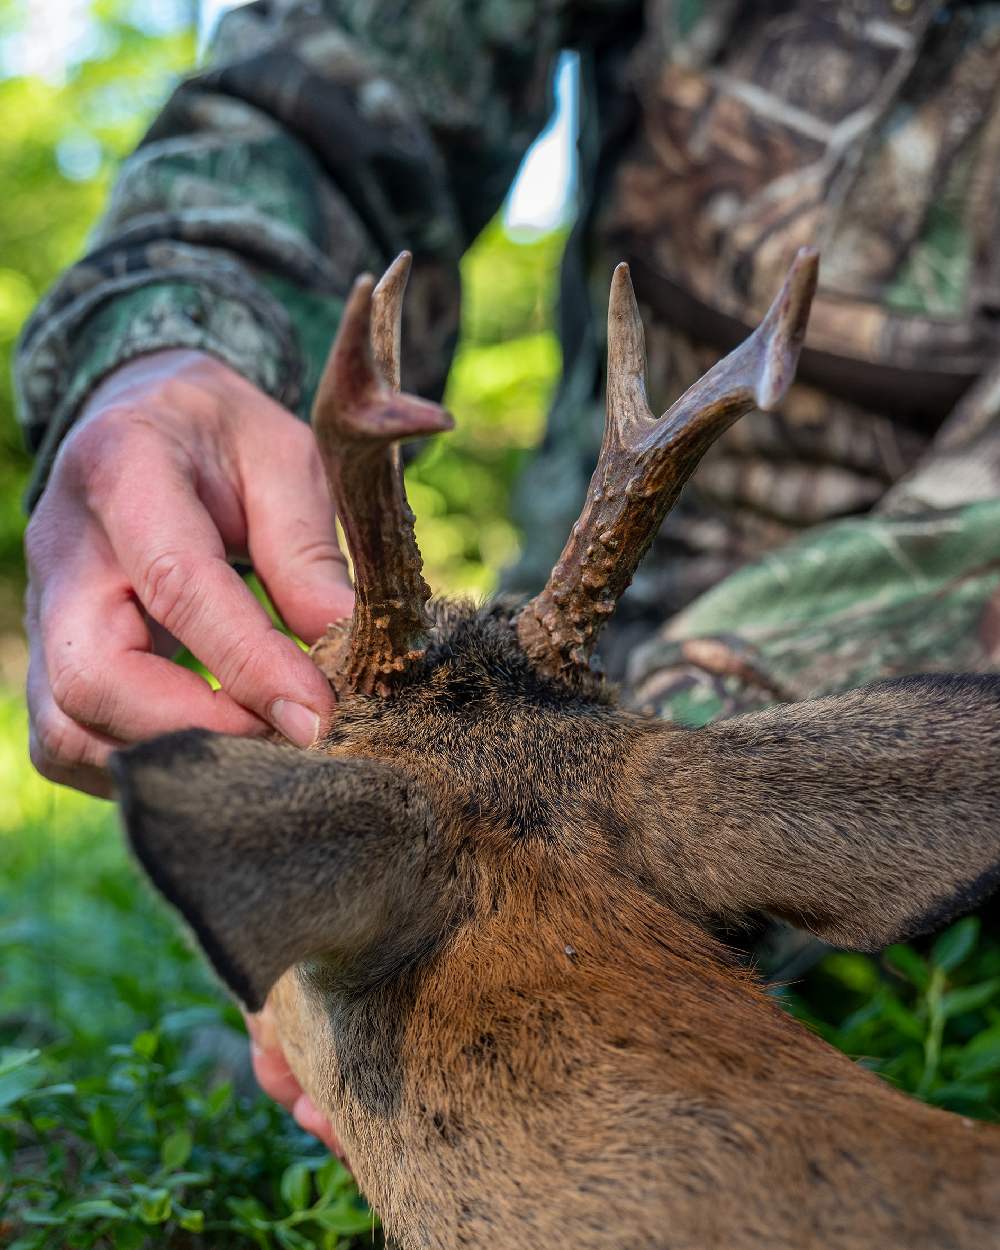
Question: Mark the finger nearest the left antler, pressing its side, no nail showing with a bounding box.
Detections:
[241,424,354,643]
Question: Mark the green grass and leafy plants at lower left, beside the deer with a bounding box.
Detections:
[0,694,381,1250]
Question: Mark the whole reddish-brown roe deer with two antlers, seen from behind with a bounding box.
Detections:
[109,250,1000,1250]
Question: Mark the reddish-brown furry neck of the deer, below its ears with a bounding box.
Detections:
[270,865,1000,1250]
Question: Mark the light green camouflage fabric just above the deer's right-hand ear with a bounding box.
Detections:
[629,365,1000,725]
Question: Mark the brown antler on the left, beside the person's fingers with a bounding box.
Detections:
[313,251,453,694]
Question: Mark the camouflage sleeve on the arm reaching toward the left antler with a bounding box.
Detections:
[15,0,577,504]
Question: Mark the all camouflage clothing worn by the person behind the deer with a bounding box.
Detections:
[18,0,1000,721]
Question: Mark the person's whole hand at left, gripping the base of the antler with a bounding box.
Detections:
[25,350,354,796]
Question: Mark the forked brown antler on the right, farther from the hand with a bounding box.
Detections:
[518,248,819,674]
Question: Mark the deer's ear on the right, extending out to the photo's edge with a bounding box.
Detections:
[645,676,1000,950]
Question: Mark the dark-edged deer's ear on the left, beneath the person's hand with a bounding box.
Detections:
[111,730,434,1011]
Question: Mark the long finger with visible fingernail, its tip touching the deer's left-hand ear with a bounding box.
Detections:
[100,439,333,746]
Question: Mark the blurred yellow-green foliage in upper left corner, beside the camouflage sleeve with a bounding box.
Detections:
[0,0,194,595]
